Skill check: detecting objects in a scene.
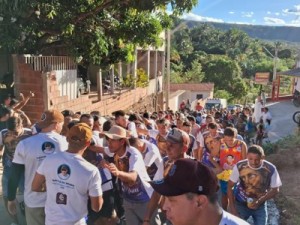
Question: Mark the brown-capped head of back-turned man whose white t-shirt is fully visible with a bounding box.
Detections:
[67,123,93,152]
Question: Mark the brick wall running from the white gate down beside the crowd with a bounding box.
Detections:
[13,55,153,123]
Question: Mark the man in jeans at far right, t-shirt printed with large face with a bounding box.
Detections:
[227,145,282,225]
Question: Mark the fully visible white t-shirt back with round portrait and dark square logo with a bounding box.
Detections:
[37,152,102,225]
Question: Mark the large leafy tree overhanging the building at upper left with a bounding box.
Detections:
[0,0,197,65]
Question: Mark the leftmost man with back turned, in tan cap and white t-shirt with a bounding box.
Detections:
[8,110,68,225]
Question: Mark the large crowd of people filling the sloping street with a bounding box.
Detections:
[0,93,282,225]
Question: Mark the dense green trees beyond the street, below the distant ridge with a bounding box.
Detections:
[171,20,295,102]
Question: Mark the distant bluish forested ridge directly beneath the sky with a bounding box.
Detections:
[186,21,300,43]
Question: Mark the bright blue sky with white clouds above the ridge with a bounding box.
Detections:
[182,0,300,27]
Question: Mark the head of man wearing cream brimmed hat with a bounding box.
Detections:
[103,125,128,153]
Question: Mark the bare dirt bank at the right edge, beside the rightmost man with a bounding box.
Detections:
[267,135,300,225]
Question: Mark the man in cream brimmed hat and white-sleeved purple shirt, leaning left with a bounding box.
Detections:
[104,125,154,225]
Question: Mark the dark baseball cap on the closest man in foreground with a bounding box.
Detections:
[150,159,219,196]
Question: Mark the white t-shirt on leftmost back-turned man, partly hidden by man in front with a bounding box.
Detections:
[13,132,68,208]
